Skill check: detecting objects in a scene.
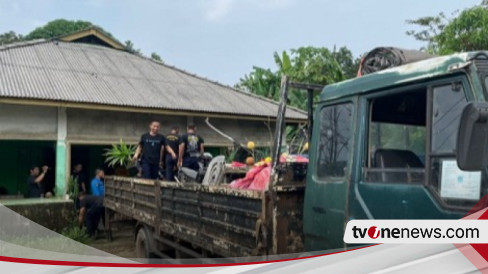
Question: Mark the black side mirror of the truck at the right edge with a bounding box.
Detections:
[456,102,488,171]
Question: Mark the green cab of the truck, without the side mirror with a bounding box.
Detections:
[303,52,488,251]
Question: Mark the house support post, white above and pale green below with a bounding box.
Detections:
[55,107,68,197]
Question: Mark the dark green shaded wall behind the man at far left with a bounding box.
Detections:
[0,140,56,195]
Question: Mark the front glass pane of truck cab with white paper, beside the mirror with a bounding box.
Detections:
[430,84,487,207]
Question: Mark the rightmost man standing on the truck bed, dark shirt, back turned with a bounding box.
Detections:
[178,124,204,171]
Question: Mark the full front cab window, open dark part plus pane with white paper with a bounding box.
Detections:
[363,81,488,209]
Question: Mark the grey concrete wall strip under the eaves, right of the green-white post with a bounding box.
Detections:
[67,109,274,146]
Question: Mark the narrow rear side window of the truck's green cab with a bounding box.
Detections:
[317,103,353,180]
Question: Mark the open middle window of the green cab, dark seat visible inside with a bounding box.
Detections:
[364,88,427,183]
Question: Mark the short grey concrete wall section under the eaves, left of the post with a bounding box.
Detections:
[0,103,58,140]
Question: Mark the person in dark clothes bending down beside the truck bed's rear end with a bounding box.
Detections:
[78,192,104,236]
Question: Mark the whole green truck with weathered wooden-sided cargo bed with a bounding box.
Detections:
[105,52,488,257]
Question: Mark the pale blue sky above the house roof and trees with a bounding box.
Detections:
[0,0,481,85]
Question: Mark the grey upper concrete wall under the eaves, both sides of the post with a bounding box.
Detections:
[0,103,274,146]
